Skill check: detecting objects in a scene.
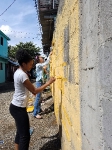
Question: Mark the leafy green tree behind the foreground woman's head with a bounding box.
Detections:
[8,42,40,59]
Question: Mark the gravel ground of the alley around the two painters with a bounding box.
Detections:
[0,83,60,150]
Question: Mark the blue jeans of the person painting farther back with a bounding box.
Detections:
[33,82,42,117]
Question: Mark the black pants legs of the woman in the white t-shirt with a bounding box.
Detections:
[10,104,30,150]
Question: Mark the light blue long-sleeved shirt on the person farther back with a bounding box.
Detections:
[36,57,50,82]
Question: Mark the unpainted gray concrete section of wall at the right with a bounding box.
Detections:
[80,0,112,150]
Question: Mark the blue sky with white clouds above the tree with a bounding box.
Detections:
[0,0,42,47]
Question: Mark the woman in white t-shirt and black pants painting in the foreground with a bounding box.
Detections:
[9,50,55,150]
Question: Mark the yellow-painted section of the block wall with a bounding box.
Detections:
[50,0,82,150]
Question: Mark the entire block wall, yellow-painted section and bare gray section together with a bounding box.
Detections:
[51,0,112,150]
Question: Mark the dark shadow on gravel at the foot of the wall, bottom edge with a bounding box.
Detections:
[39,134,61,150]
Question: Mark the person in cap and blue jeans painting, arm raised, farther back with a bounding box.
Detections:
[33,52,52,119]
